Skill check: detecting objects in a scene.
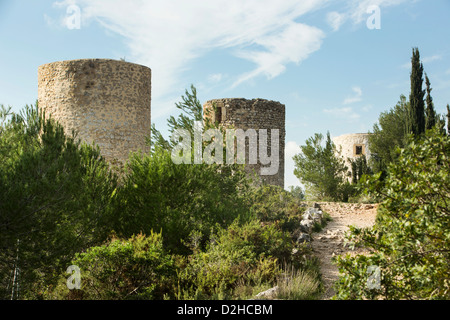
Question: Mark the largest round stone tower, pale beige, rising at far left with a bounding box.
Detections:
[38,59,151,164]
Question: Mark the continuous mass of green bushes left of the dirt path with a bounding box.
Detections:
[0,88,321,299]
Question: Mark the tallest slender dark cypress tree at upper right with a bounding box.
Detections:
[407,48,425,135]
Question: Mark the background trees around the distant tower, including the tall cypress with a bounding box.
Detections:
[294,48,450,202]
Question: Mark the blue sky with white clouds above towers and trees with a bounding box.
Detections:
[0,0,450,187]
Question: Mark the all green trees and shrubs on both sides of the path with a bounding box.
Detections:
[0,50,450,299]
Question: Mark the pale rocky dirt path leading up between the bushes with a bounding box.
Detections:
[311,202,377,300]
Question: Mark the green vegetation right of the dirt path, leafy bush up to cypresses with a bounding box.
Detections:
[335,49,450,299]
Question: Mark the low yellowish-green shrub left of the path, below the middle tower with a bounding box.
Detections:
[180,220,293,297]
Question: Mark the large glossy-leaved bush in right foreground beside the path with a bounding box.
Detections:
[336,129,450,299]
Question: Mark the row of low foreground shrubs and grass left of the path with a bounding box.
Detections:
[42,216,321,300]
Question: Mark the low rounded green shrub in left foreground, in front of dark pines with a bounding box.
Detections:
[49,233,176,300]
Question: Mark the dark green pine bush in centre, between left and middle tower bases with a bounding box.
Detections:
[110,148,248,254]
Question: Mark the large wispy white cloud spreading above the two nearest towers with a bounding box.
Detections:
[52,0,326,109]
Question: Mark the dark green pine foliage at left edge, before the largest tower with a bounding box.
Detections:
[0,105,117,298]
